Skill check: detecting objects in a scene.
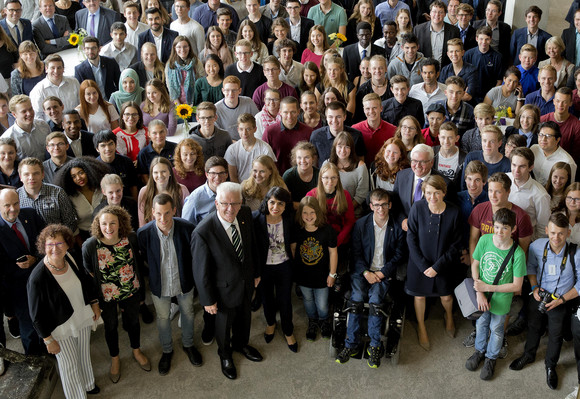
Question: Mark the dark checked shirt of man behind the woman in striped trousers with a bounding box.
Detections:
[16,183,77,233]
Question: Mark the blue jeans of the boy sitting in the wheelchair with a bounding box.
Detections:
[345,275,389,348]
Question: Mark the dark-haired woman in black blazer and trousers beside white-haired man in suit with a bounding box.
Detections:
[253,186,298,352]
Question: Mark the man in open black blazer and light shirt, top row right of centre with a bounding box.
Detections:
[413,0,459,67]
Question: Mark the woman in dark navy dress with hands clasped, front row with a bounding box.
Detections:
[405,175,462,350]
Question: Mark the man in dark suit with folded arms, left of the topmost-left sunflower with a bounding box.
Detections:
[32,0,72,58]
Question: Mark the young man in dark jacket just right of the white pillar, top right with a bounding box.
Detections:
[510,6,552,65]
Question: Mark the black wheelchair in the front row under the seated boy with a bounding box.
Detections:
[329,276,406,365]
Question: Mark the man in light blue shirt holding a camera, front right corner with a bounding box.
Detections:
[510,213,580,389]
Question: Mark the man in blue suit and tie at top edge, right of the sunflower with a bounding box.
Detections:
[75,0,123,45]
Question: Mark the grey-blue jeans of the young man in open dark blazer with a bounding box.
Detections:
[151,290,193,353]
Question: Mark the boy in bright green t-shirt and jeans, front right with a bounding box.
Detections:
[465,208,526,380]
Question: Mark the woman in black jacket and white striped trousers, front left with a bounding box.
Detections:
[27,224,101,398]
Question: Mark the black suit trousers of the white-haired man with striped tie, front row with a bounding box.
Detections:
[215,287,252,359]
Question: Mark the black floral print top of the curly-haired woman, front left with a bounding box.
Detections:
[97,237,140,302]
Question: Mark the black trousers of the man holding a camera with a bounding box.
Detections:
[524,297,568,367]
